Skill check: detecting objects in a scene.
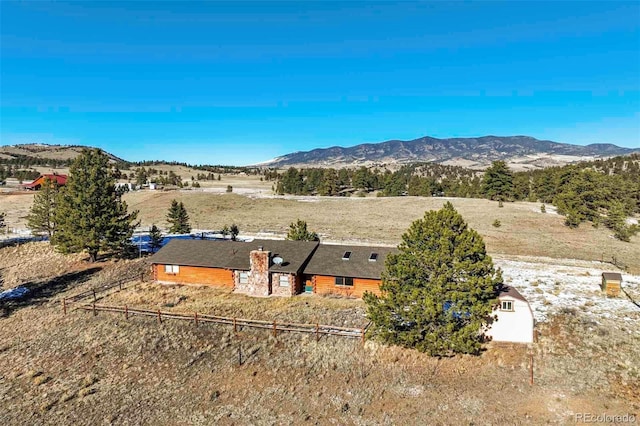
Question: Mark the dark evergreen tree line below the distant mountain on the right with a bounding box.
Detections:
[272,154,640,241]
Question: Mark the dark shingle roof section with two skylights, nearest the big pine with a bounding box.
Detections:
[304,244,398,279]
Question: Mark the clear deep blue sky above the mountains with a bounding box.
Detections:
[0,0,640,165]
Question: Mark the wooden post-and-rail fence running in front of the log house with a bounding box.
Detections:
[70,299,369,343]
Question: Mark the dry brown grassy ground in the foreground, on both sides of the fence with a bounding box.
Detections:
[0,243,640,425]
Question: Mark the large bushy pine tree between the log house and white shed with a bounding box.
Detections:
[364,202,502,356]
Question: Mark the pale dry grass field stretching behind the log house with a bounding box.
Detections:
[0,182,640,273]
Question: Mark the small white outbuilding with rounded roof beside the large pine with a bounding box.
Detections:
[485,286,534,343]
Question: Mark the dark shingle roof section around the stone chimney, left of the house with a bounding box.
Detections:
[151,239,318,273]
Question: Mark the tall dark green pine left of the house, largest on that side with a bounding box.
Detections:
[52,149,138,262]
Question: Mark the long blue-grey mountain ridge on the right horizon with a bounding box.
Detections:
[265,136,637,169]
